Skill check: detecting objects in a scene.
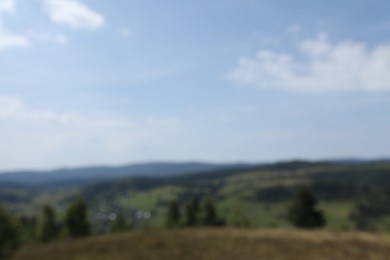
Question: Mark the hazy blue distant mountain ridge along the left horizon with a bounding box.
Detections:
[0,162,250,189]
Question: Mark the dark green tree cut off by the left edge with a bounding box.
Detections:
[0,205,20,259]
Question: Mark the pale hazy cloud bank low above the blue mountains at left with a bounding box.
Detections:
[0,96,181,170]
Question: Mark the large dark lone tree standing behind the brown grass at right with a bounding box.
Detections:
[288,187,325,228]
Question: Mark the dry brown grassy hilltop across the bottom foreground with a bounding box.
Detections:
[14,229,390,260]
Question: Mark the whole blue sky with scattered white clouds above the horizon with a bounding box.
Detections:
[0,0,390,171]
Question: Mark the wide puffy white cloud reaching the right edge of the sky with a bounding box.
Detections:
[229,33,390,92]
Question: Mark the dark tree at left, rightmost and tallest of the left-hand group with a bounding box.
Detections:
[65,198,90,237]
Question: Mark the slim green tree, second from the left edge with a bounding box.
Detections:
[37,205,58,242]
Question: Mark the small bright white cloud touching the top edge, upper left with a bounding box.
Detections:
[44,0,104,30]
